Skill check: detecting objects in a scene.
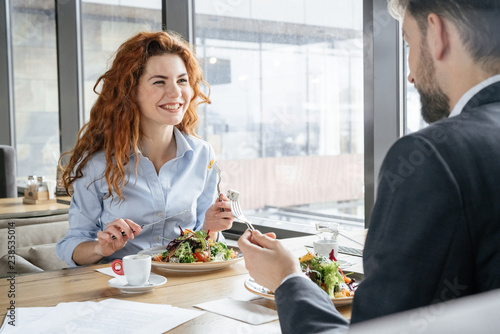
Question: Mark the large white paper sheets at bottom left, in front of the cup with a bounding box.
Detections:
[1,299,203,334]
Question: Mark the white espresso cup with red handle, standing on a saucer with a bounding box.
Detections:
[111,254,151,285]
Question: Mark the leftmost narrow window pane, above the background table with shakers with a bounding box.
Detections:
[11,0,60,179]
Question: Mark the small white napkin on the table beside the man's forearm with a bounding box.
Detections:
[194,298,278,325]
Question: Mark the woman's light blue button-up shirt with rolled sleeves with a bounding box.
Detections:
[56,129,220,266]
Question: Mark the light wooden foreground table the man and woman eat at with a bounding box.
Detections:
[0,232,364,334]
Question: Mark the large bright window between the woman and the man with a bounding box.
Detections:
[195,0,364,231]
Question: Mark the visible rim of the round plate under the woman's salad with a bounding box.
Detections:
[139,246,243,273]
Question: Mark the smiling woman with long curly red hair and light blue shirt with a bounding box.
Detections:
[57,32,234,265]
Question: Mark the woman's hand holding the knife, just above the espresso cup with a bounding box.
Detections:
[95,218,142,257]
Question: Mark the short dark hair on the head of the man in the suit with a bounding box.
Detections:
[388,0,500,73]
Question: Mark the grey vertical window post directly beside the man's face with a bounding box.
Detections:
[363,0,404,228]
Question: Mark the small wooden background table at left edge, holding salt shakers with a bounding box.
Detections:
[0,197,69,219]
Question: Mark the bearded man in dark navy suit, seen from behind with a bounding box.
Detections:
[239,0,500,333]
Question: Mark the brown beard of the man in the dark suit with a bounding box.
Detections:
[415,39,450,123]
